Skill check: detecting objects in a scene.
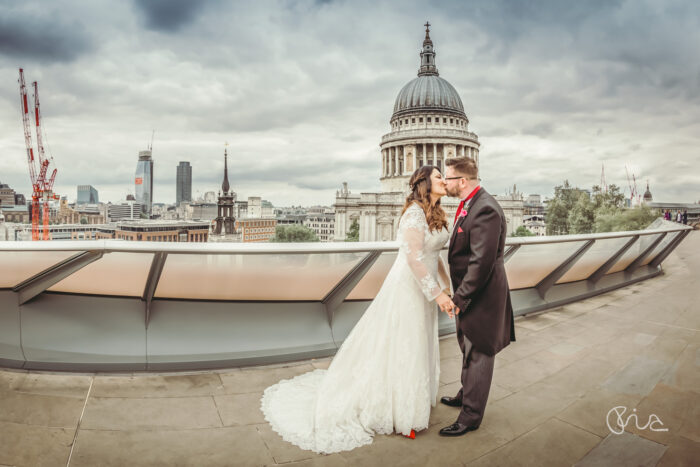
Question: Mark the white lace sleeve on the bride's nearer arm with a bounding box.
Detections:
[399,204,441,300]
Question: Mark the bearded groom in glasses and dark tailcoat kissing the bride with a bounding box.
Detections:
[440,158,515,436]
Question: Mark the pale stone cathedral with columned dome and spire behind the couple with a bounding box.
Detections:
[335,23,523,242]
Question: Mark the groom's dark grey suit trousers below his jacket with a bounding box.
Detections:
[456,326,496,427]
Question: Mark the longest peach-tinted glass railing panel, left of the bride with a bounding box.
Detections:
[155,253,367,301]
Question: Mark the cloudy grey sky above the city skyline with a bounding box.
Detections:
[0,0,700,206]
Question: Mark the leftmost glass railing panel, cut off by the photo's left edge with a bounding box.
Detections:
[0,250,80,287]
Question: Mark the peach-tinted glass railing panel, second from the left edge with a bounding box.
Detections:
[48,252,153,297]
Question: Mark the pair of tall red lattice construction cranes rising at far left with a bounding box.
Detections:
[19,68,58,240]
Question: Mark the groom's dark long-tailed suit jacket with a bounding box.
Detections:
[448,188,515,355]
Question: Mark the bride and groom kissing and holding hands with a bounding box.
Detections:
[261,158,515,454]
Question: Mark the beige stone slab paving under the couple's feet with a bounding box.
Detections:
[0,232,700,467]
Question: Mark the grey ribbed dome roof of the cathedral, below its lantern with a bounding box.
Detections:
[391,74,466,119]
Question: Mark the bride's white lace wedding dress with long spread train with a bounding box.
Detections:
[261,203,449,453]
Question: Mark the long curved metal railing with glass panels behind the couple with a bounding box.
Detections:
[0,220,691,371]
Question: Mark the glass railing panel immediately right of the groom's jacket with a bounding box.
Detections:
[506,242,585,290]
